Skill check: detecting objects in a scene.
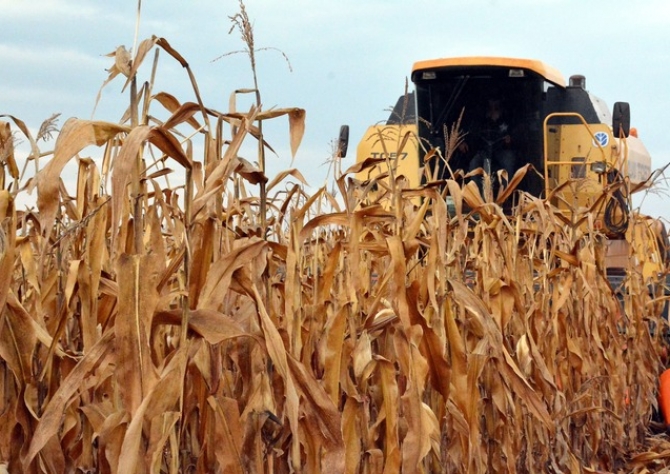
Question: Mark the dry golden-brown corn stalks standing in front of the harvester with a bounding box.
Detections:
[0,5,670,474]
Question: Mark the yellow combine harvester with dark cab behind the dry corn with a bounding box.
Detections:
[350,57,668,284]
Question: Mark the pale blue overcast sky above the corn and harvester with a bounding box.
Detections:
[0,0,670,218]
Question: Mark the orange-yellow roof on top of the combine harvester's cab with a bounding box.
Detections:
[412,56,565,87]
